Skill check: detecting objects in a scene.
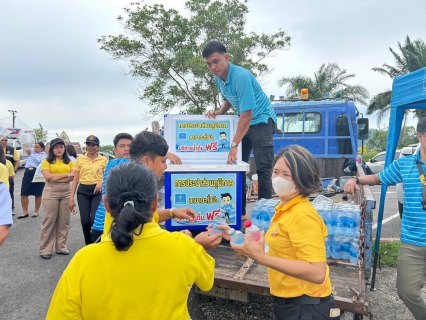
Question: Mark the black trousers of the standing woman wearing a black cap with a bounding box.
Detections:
[77,184,102,245]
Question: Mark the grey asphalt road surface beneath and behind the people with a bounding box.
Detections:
[0,169,400,320]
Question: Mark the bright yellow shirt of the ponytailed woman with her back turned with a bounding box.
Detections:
[46,222,214,320]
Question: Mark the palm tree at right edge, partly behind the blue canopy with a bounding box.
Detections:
[367,36,426,124]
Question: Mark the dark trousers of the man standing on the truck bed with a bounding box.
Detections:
[241,118,275,215]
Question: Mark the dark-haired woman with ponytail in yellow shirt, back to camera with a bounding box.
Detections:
[47,163,214,320]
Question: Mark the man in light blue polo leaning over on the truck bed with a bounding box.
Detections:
[202,41,277,219]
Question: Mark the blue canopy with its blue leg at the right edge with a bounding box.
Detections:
[371,68,426,290]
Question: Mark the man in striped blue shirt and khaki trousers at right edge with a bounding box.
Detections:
[345,117,426,320]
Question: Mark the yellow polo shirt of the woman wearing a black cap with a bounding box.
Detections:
[75,153,108,185]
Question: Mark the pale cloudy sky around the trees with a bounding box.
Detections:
[0,0,426,145]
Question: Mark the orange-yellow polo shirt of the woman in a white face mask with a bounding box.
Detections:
[265,196,332,298]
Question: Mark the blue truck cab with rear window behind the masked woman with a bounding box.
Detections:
[272,99,368,178]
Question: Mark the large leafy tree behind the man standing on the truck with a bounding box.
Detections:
[98,0,291,116]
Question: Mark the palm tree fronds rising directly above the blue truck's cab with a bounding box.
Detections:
[278,63,368,104]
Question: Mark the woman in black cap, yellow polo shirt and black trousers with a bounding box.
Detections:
[69,135,108,245]
